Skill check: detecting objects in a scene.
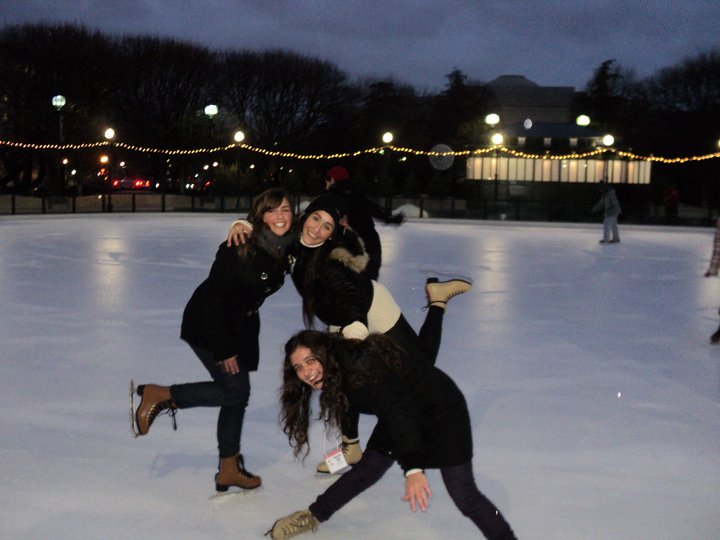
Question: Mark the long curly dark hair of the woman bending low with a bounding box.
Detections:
[279,330,406,459]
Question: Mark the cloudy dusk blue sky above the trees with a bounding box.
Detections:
[0,0,720,92]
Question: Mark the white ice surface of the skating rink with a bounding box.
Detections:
[0,214,720,540]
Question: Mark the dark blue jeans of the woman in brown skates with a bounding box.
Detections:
[170,345,250,458]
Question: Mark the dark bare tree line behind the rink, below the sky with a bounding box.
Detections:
[0,24,720,202]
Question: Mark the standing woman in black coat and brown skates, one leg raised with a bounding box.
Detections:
[135,189,294,491]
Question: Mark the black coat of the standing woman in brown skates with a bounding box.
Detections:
[180,242,288,371]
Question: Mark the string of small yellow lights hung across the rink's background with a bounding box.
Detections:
[0,140,720,164]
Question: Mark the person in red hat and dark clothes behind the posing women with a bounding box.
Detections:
[325,166,404,279]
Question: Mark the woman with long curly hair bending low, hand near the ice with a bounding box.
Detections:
[269,330,515,540]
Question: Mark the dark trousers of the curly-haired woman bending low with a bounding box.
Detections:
[310,450,515,540]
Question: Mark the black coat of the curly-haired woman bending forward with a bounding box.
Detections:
[334,343,473,471]
